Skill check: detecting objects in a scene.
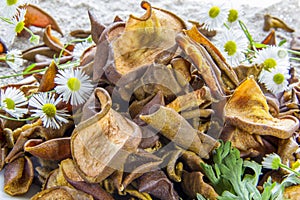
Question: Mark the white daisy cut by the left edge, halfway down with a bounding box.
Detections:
[0,87,28,119]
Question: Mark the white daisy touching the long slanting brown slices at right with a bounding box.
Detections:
[215,29,248,67]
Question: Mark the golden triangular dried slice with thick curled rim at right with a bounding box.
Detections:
[225,78,299,139]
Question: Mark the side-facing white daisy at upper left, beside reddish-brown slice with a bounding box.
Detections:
[6,8,26,44]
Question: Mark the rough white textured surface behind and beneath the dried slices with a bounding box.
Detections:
[0,0,300,200]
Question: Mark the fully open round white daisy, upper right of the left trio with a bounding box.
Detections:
[55,69,94,106]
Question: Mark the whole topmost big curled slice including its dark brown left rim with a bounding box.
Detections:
[94,1,186,83]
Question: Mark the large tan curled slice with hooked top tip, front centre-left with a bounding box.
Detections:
[71,88,141,182]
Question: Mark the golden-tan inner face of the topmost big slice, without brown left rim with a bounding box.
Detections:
[113,1,185,75]
